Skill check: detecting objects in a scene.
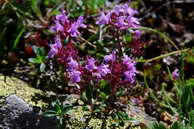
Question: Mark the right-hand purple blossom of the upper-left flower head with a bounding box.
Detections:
[68,16,86,37]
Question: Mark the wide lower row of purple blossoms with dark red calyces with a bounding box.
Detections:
[67,51,138,85]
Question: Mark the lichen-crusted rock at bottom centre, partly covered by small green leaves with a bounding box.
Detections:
[65,105,154,129]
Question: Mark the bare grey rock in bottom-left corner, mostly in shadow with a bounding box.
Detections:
[0,95,56,129]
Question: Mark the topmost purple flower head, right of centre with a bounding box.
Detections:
[96,4,140,35]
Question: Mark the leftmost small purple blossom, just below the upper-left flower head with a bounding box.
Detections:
[48,36,62,58]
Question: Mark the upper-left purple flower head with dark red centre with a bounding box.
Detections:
[50,11,86,37]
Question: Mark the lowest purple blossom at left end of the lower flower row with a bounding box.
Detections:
[68,70,81,83]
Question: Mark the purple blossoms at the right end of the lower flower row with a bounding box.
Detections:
[123,55,138,84]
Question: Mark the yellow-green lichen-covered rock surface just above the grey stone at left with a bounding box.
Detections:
[0,75,48,107]
